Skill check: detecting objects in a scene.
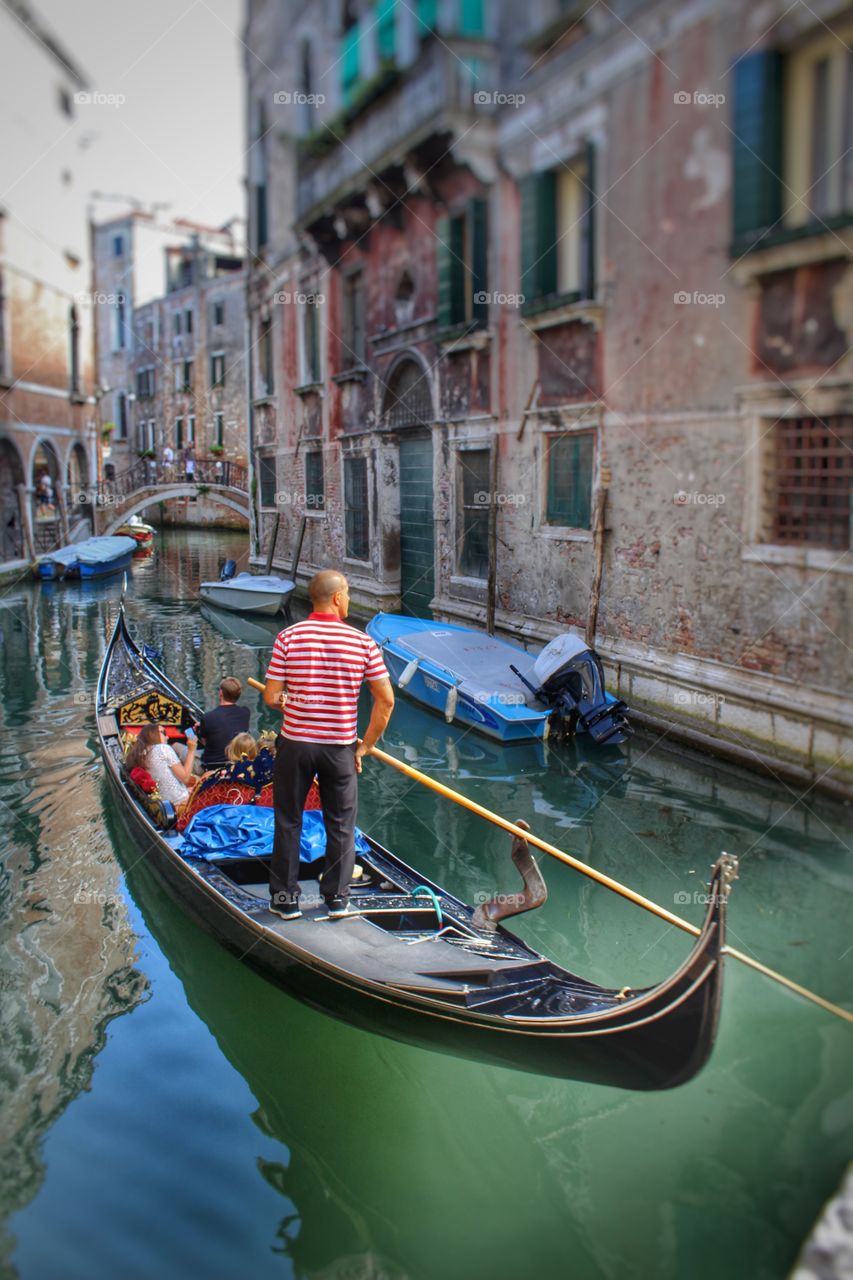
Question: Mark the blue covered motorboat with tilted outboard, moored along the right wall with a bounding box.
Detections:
[366,613,628,746]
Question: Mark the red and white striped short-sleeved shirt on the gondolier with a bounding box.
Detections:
[266,613,388,746]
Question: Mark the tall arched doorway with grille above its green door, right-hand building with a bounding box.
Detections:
[383,356,435,618]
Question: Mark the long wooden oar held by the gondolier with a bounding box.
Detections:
[242,676,853,1023]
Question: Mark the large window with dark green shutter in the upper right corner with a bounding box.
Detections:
[733,34,853,252]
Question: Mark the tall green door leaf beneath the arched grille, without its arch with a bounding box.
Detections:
[400,434,435,618]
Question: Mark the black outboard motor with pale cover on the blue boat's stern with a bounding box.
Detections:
[512,634,629,745]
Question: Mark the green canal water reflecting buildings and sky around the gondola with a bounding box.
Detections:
[0,532,853,1280]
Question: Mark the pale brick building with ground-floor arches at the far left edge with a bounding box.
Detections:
[0,0,97,563]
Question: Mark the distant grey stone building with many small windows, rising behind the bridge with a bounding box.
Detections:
[93,212,247,496]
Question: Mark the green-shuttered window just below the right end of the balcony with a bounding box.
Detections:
[437,197,488,328]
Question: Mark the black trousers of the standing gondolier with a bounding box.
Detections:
[269,733,359,899]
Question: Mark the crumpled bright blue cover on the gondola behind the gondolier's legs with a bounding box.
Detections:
[181,804,370,863]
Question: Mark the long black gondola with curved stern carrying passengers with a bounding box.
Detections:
[96,604,736,1089]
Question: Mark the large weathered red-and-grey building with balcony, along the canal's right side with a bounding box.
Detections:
[245,0,853,790]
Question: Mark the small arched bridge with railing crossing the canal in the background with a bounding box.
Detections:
[93,458,250,534]
